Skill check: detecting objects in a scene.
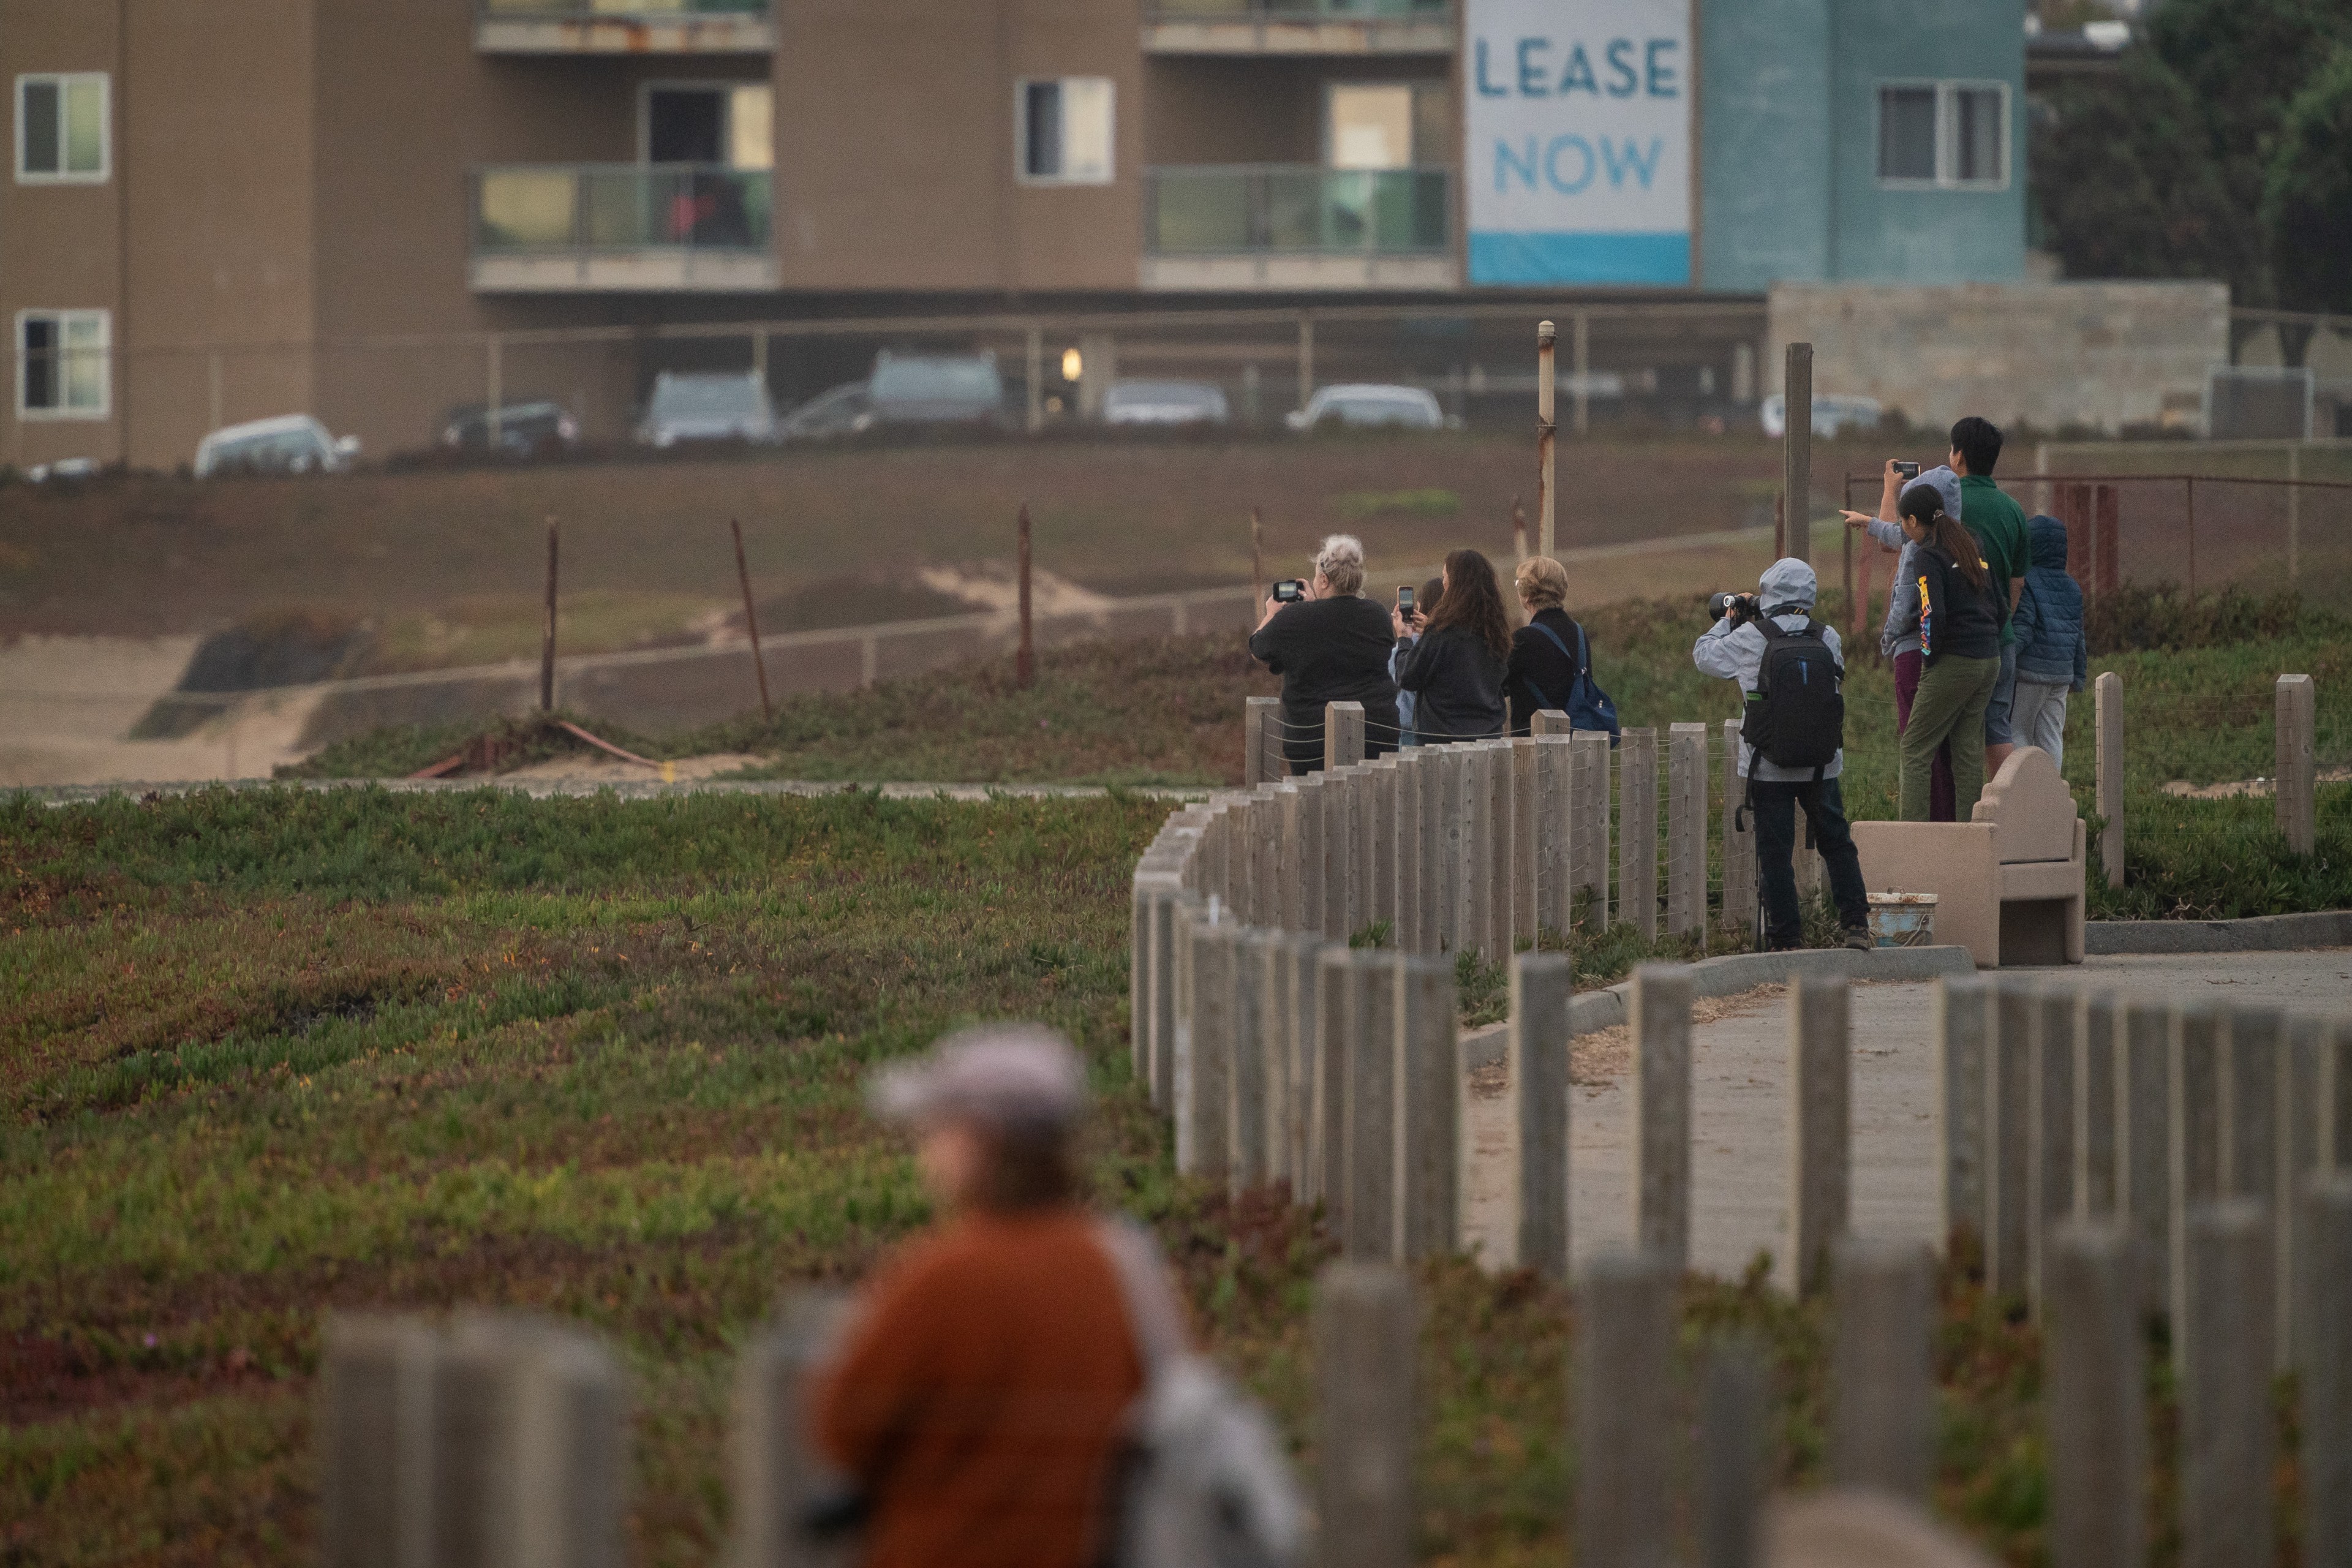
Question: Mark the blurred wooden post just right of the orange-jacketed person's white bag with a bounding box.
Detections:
[1315,1262,1420,1568]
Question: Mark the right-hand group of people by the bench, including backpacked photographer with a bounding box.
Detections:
[1691,416,2089,948]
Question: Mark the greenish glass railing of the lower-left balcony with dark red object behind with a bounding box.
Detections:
[473,165,772,256]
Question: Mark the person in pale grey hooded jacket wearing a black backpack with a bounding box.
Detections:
[1691,557,1870,948]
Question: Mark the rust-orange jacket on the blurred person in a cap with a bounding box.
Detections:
[814,1208,1143,1568]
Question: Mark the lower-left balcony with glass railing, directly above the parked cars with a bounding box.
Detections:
[470,165,778,294]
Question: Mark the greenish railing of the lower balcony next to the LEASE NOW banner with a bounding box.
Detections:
[1143,165,1453,256]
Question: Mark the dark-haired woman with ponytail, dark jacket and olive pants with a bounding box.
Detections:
[1898,484,2007,823]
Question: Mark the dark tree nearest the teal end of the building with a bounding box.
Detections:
[2032,50,2263,294]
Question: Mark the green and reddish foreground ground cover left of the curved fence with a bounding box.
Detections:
[0,790,2288,1568]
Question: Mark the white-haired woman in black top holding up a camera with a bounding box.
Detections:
[1249,533,1397,774]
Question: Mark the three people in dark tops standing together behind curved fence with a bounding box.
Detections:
[1249,533,1593,774]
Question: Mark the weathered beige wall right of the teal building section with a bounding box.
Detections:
[1764,282,2230,430]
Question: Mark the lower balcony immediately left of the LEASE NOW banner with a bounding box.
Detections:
[1143,165,1461,289]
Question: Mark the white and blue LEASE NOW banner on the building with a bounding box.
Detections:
[1461,0,1694,284]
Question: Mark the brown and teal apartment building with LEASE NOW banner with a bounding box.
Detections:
[0,0,2025,466]
